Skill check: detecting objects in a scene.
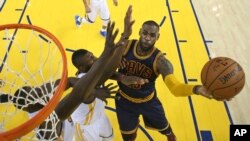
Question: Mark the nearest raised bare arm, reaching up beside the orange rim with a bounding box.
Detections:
[55,23,122,120]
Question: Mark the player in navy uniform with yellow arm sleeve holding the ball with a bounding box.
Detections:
[116,21,228,141]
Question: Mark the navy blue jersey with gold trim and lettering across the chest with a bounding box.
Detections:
[118,40,161,100]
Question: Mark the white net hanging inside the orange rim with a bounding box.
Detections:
[0,26,63,140]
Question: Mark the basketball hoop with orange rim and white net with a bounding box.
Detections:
[0,24,67,141]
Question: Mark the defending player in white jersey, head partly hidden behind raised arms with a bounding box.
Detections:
[71,49,147,141]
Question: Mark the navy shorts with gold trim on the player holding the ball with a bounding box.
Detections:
[115,93,169,134]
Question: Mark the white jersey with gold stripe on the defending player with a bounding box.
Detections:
[71,73,114,141]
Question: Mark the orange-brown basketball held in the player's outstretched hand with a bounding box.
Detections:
[201,57,245,99]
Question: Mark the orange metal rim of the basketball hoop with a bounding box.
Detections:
[0,24,68,141]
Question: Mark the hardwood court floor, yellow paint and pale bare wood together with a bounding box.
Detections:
[0,0,250,141]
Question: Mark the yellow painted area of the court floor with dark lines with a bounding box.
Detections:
[0,0,232,141]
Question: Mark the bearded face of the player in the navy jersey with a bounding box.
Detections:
[139,24,159,51]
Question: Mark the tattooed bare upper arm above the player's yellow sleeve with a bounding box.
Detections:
[157,55,174,79]
